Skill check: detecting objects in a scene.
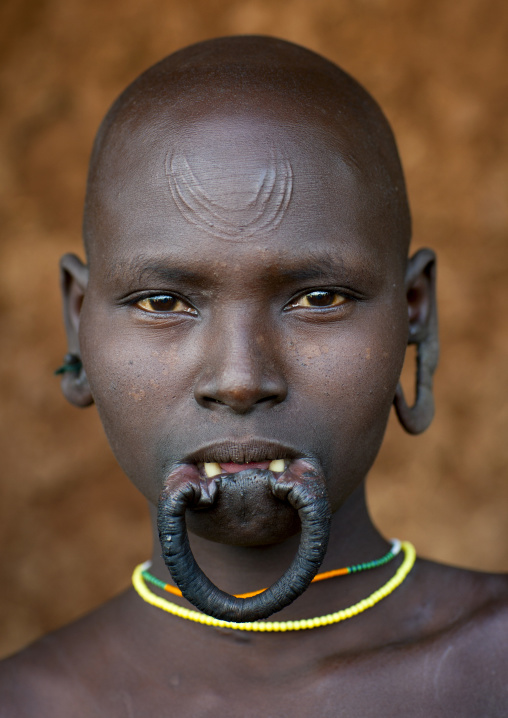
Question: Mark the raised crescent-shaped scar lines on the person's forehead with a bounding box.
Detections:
[165,148,293,240]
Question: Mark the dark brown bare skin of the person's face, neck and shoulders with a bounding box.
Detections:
[0,39,508,718]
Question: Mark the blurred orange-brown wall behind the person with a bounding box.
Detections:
[0,0,508,655]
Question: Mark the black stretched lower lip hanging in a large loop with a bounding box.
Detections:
[158,460,331,623]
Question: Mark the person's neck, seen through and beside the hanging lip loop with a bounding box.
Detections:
[150,485,388,620]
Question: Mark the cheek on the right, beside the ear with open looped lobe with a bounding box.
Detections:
[288,317,405,500]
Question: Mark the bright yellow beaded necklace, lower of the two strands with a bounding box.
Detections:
[132,541,416,633]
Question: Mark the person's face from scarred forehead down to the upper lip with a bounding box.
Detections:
[74,111,408,543]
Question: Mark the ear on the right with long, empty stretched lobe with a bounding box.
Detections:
[393,249,439,434]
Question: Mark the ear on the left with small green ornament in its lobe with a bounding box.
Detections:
[60,254,93,407]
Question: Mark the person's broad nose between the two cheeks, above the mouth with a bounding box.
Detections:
[194,321,287,414]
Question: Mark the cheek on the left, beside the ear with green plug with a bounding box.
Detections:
[81,315,193,500]
